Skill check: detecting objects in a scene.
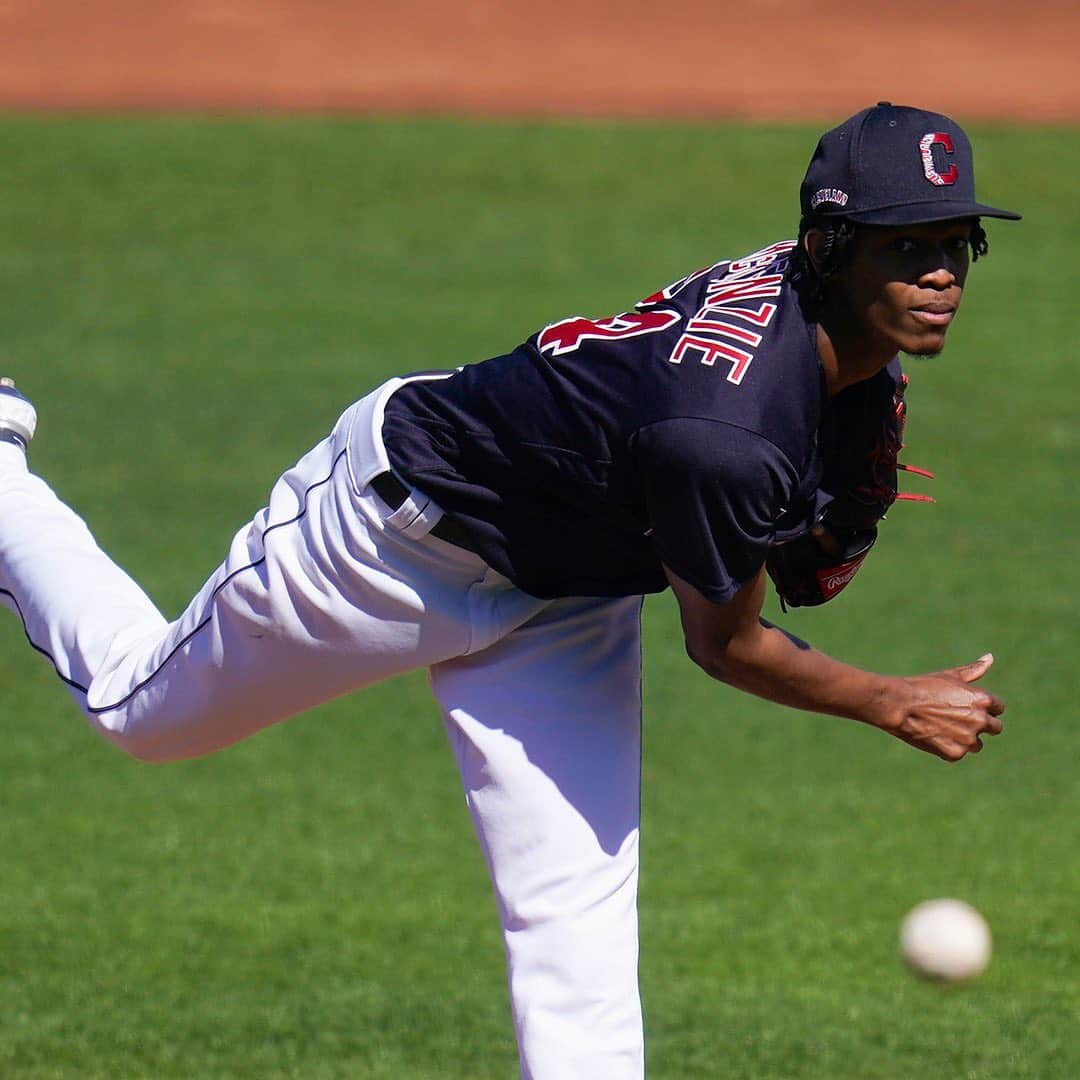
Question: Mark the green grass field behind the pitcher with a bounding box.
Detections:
[0,118,1080,1080]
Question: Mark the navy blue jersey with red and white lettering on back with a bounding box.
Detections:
[383,242,828,603]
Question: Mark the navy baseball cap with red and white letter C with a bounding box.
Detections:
[799,102,1020,225]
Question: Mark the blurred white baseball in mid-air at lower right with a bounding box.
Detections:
[900,900,990,982]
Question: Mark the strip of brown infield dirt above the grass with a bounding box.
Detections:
[0,0,1080,123]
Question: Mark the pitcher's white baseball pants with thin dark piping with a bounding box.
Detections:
[0,380,644,1080]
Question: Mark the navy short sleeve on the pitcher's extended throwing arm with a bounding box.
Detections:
[635,418,798,604]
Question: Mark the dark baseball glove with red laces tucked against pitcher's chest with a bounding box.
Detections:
[765,362,933,611]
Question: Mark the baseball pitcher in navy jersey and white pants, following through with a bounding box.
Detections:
[0,103,1017,1080]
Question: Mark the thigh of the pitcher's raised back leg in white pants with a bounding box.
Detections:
[73,410,524,759]
